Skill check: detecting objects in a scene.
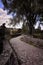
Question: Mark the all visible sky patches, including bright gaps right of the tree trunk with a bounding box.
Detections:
[0,0,43,30]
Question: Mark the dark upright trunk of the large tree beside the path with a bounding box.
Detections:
[27,13,35,35]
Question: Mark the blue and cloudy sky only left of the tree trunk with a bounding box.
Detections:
[0,0,22,28]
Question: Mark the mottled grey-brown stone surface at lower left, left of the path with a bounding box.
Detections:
[0,41,12,65]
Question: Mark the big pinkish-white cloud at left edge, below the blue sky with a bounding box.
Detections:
[0,8,11,25]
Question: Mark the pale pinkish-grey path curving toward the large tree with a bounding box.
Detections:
[10,36,43,65]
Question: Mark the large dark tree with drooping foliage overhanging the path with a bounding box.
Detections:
[2,0,42,34]
